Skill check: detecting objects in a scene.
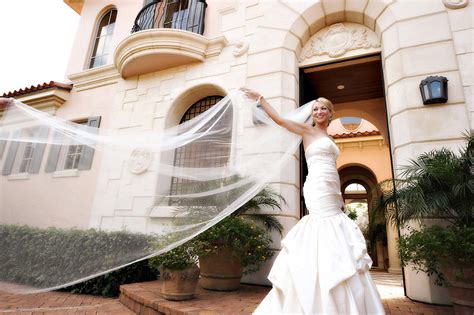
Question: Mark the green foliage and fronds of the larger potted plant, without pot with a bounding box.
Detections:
[174,176,285,273]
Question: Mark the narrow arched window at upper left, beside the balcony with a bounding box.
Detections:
[89,9,117,68]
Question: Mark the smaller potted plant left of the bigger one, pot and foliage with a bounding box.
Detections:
[149,242,199,301]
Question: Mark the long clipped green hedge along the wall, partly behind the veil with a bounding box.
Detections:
[0,225,153,295]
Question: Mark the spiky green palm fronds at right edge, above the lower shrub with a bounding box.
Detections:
[372,132,474,227]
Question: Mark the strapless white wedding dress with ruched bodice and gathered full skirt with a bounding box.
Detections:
[254,137,384,315]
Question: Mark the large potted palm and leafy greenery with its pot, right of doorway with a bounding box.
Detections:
[374,132,474,314]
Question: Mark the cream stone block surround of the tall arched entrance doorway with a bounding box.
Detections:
[247,0,474,304]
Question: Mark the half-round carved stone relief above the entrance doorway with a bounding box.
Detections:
[299,23,380,62]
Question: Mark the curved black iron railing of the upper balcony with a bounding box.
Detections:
[132,0,207,35]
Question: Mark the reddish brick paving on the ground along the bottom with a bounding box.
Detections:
[0,272,453,315]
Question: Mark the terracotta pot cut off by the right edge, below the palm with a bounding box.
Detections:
[443,266,474,315]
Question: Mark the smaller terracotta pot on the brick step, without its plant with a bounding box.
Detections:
[160,266,199,301]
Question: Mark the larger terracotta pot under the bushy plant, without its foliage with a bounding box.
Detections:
[199,247,242,291]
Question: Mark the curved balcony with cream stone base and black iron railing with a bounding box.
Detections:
[114,0,227,78]
